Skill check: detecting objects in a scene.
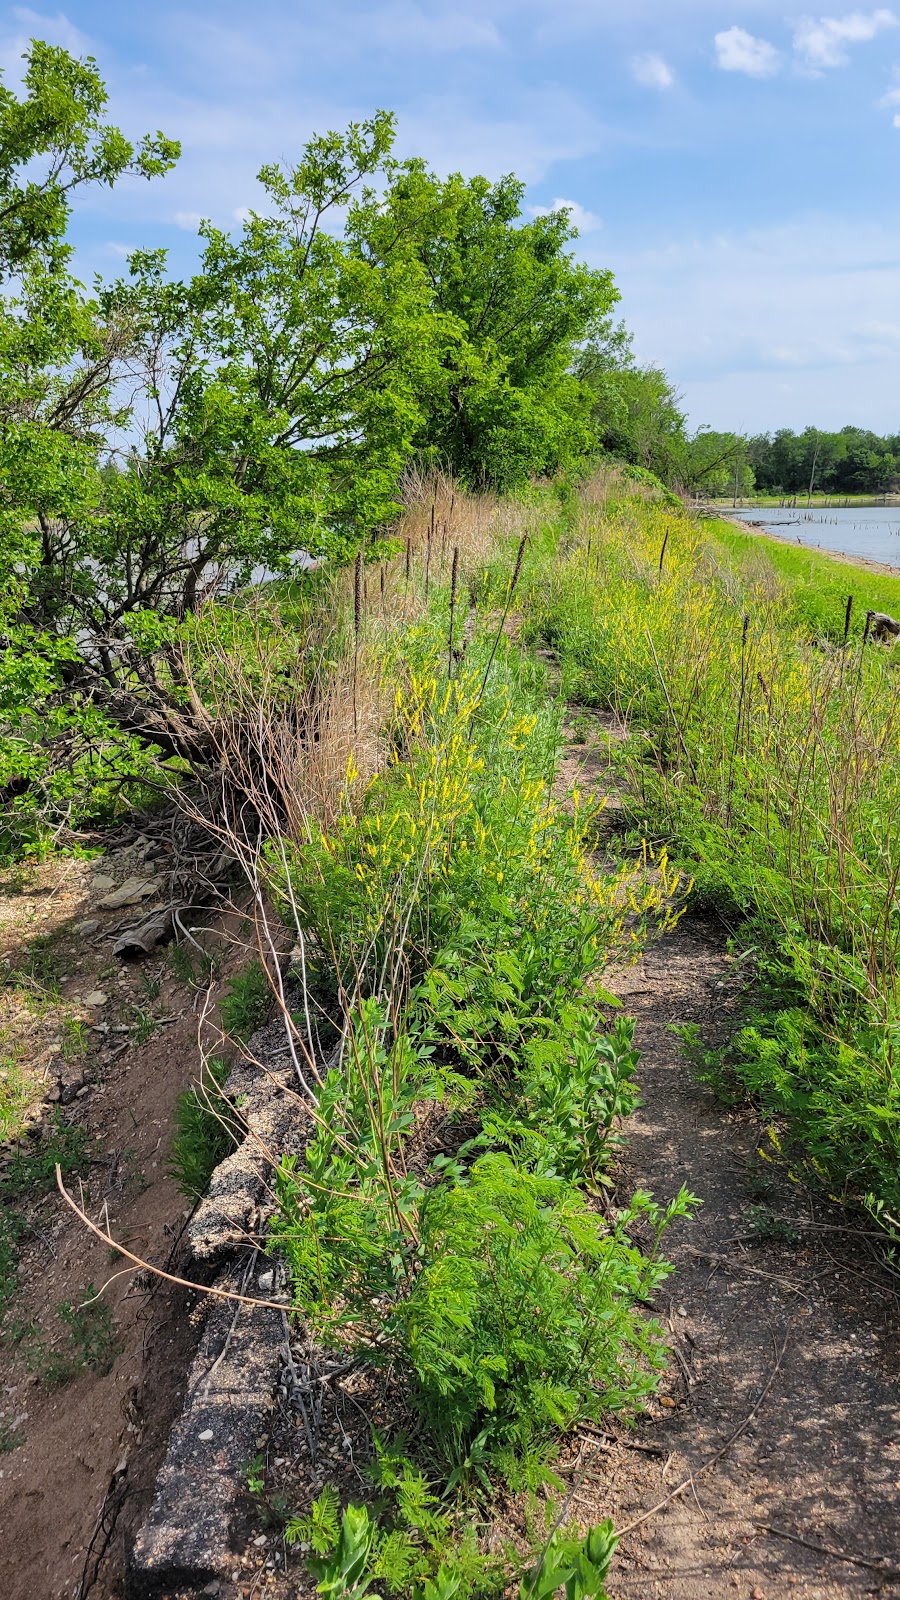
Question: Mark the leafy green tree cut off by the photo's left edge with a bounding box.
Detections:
[0,40,178,838]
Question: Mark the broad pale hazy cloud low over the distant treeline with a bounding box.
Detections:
[583,214,900,432]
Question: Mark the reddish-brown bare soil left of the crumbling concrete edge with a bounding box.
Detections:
[0,835,253,1600]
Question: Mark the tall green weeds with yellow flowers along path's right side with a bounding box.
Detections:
[530,470,900,1219]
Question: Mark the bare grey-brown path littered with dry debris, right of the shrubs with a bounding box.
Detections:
[554,712,900,1600]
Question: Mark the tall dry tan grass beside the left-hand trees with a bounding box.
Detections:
[181,472,538,876]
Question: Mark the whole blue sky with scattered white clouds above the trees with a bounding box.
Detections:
[0,0,900,432]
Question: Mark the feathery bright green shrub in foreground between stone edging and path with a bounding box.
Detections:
[388,1154,687,1470]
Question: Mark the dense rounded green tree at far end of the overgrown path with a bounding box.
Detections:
[372,162,618,490]
